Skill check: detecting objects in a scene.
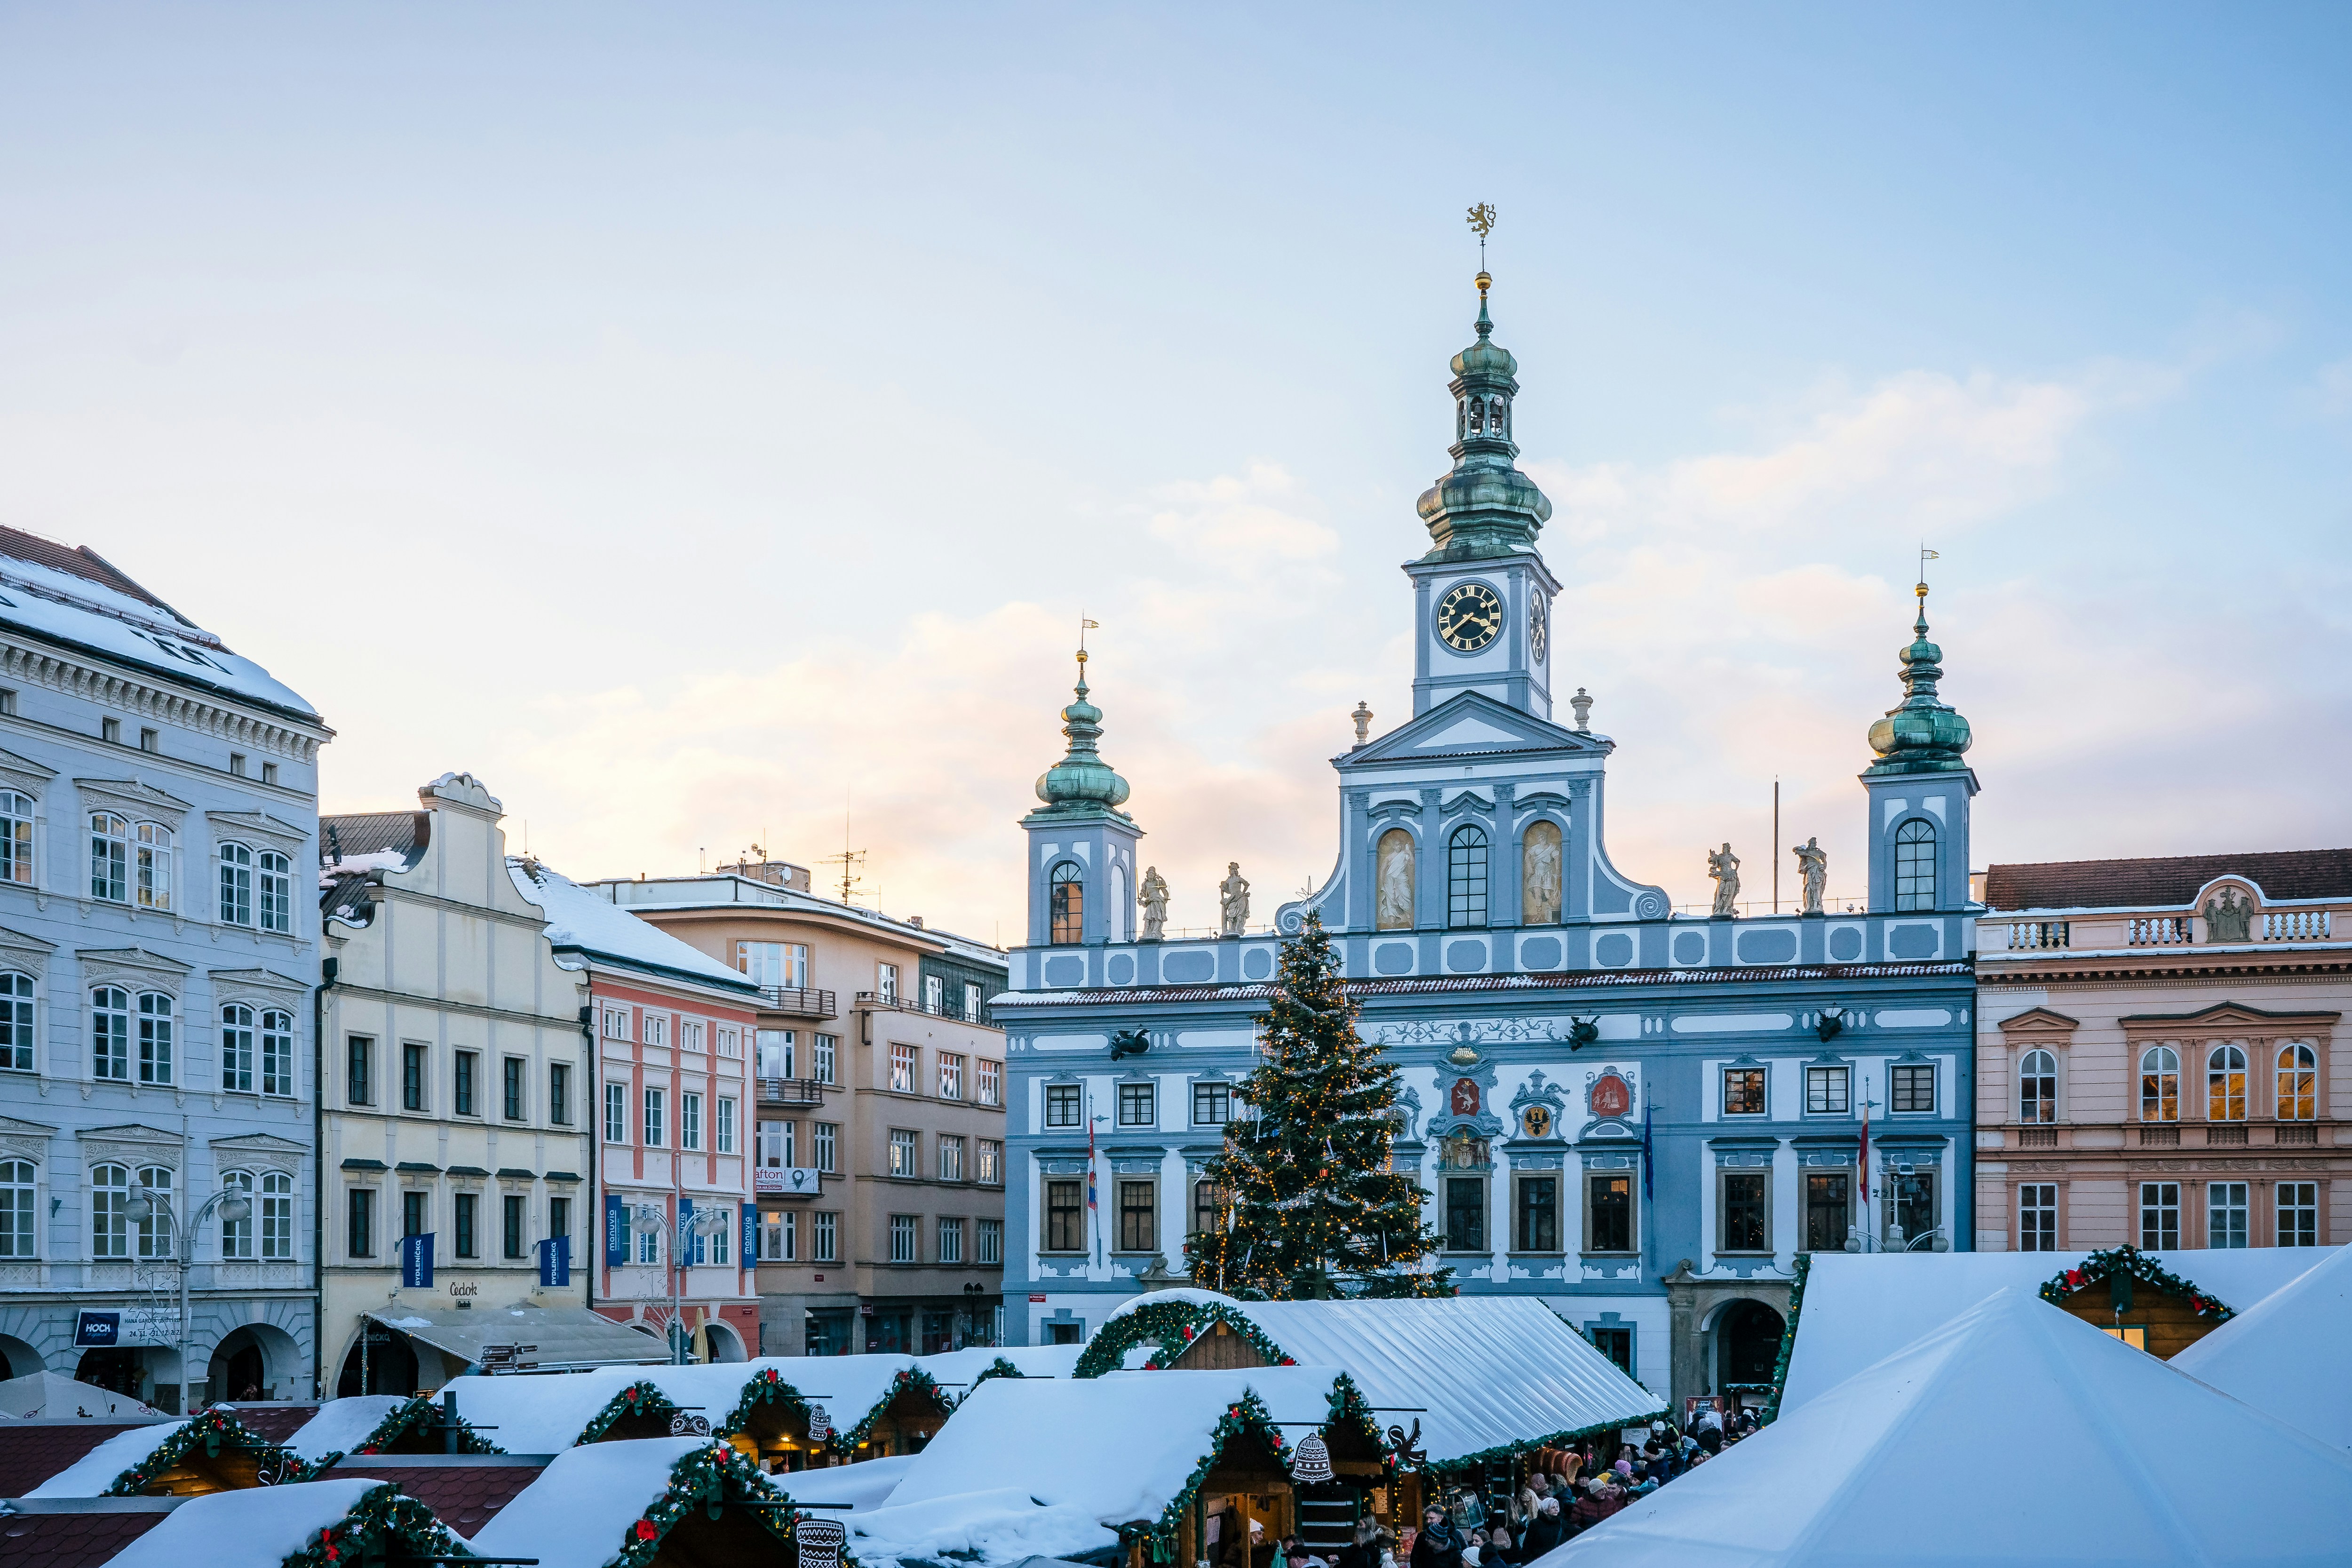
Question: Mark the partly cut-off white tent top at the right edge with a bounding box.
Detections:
[2171,1246,2352,1448]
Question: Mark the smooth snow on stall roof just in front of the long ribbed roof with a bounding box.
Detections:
[884,1366,1338,1526]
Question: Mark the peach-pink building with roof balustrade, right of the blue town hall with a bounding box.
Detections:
[1976,849,2352,1260]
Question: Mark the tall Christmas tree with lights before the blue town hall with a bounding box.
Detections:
[1185,915,1454,1300]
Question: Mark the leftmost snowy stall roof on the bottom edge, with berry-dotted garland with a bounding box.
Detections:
[106,1481,463,1568]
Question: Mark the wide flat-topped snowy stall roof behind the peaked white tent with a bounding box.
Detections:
[1780,1246,2331,1415]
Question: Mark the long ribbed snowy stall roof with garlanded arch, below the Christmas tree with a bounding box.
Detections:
[1087,1290,1665,1465]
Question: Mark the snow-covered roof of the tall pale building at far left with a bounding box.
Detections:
[0,529,318,724]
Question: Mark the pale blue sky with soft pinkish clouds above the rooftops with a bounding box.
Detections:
[0,5,2352,943]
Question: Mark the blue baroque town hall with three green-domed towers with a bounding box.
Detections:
[995,275,1976,1399]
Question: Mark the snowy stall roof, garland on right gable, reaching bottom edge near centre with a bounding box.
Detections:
[880,1366,1341,1561]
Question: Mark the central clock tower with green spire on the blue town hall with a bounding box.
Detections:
[1404,273,1559,719]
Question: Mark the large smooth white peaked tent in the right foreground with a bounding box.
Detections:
[1538,1288,2352,1568]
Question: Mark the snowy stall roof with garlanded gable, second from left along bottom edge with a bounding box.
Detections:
[470,1436,800,1568]
